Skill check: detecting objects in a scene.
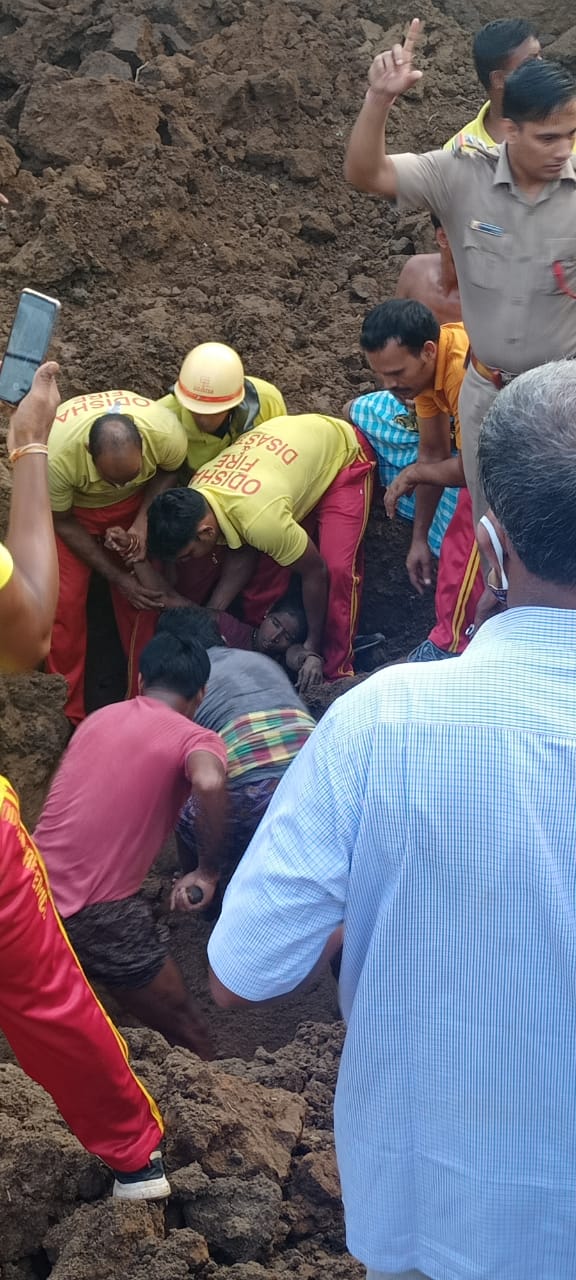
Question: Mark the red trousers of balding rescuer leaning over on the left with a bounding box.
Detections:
[46,494,146,724]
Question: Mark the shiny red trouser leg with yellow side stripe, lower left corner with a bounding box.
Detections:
[0,777,163,1172]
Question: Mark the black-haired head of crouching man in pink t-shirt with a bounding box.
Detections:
[138,631,210,719]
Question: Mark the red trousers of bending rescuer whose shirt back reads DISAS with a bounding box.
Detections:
[243,431,376,680]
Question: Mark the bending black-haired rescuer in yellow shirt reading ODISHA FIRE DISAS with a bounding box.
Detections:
[148,413,375,690]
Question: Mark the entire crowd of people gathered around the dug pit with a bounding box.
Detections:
[0,18,576,1280]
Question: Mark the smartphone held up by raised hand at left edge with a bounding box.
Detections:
[0,289,60,404]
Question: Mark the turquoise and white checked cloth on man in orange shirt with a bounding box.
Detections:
[349,392,460,556]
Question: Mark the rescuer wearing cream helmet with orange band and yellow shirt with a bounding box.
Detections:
[159,342,287,471]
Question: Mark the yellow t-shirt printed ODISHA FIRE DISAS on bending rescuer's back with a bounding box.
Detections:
[191,413,360,564]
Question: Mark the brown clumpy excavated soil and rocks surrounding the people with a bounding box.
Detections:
[0,0,576,1280]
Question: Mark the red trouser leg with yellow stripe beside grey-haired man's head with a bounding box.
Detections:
[428,489,484,653]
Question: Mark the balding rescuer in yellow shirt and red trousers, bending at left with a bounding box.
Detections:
[47,390,186,724]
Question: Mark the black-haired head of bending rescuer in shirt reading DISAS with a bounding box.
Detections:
[148,489,220,559]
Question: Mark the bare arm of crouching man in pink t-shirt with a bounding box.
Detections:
[172,751,228,911]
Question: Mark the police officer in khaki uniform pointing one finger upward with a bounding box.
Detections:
[346,19,576,521]
